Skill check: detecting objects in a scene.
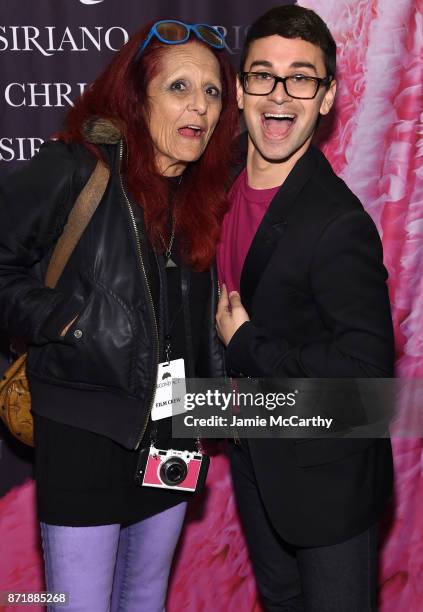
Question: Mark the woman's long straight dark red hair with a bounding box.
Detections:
[59,22,238,270]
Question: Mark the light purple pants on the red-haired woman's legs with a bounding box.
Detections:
[41,502,187,612]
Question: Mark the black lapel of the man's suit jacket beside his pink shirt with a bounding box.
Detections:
[241,147,317,312]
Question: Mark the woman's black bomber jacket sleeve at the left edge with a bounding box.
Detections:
[0,142,83,344]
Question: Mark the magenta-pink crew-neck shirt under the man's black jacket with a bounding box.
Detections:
[217,168,279,292]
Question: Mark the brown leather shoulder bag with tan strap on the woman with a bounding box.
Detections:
[0,161,110,446]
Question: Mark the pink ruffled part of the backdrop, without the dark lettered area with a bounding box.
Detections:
[0,0,423,612]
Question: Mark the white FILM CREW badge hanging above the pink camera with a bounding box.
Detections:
[151,359,186,421]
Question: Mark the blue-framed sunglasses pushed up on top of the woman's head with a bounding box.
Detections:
[135,19,225,59]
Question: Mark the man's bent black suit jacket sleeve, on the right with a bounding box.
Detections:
[227,211,394,378]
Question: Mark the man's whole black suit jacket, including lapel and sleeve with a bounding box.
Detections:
[227,141,394,546]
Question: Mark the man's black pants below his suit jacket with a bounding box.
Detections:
[230,440,377,612]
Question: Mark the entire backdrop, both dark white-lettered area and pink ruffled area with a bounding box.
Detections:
[0,0,423,612]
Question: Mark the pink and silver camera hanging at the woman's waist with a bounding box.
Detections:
[135,446,210,493]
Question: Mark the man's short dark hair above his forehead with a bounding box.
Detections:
[241,5,336,77]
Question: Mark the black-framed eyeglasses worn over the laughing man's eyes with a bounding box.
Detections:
[240,72,332,100]
